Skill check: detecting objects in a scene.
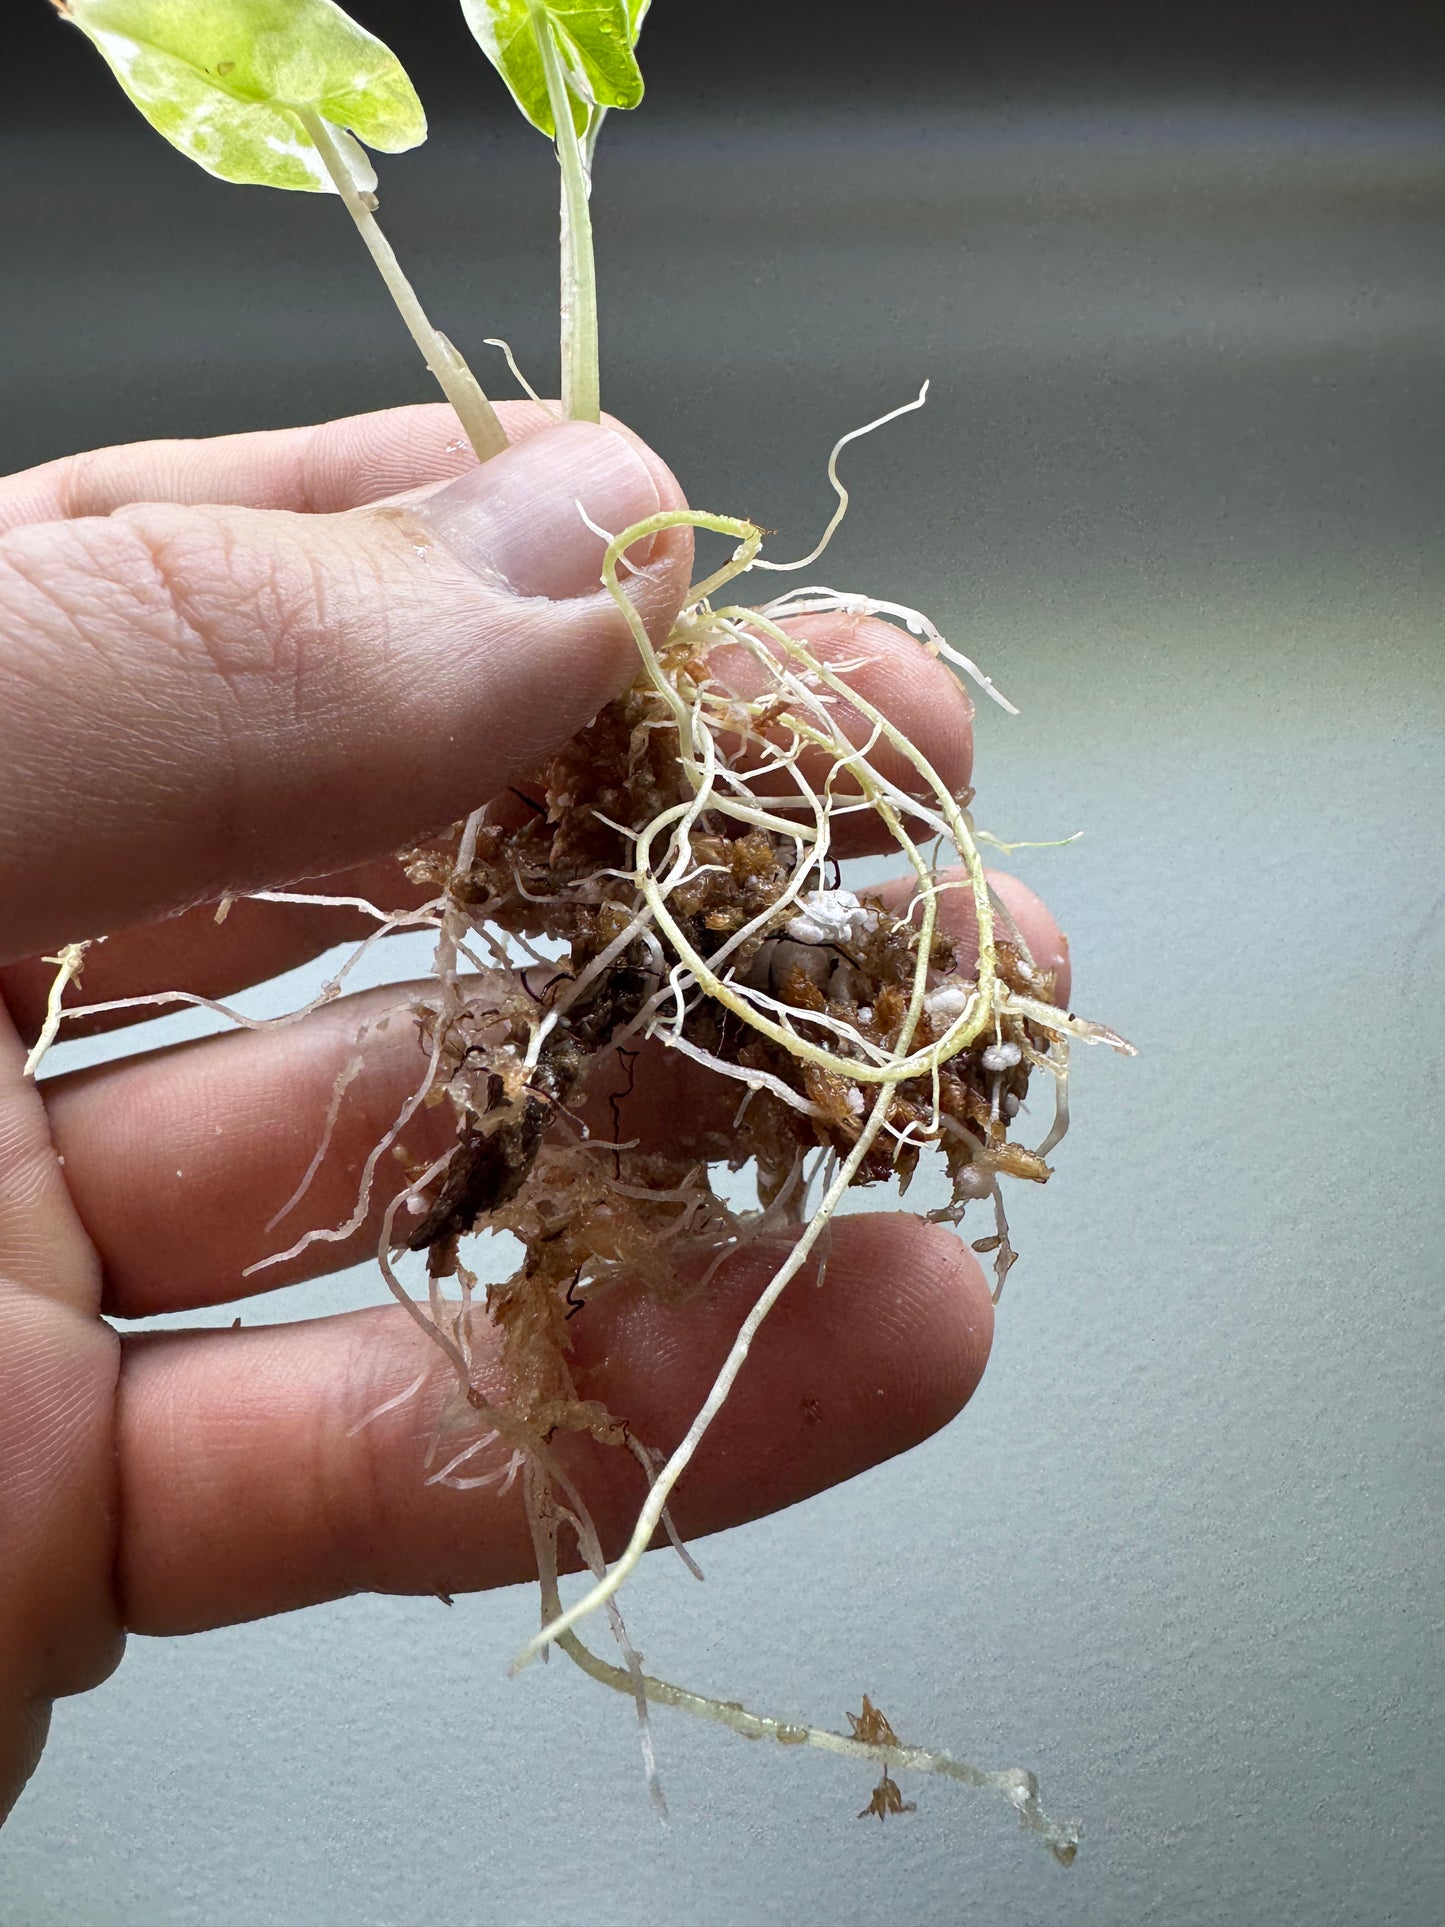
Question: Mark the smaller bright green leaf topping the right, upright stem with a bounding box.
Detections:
[462,0,651,139]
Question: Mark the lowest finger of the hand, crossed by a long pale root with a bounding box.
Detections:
[118,1216,992,1634]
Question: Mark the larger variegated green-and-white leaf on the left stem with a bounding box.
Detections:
[54,0,426,193]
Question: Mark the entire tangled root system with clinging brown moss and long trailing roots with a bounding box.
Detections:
[37,470,1129,1861]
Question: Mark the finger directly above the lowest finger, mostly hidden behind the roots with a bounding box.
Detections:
[44,873,1067,1318]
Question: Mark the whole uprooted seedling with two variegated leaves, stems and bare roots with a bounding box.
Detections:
[45,0,1129,1863]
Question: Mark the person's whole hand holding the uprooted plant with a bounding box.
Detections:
[0,405,1067,1815]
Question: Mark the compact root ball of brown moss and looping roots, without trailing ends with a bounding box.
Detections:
[391,518,1102,1488]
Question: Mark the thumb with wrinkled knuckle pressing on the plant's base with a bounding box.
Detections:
[0,422,692,962]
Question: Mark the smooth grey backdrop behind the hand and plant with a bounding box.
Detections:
[0,10,1445,1927]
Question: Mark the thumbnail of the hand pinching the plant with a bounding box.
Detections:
[412,422,661,601]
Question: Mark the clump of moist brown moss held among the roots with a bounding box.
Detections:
[396,688,1052,1443]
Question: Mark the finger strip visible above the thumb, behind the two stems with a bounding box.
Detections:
[0,401,566,534]
